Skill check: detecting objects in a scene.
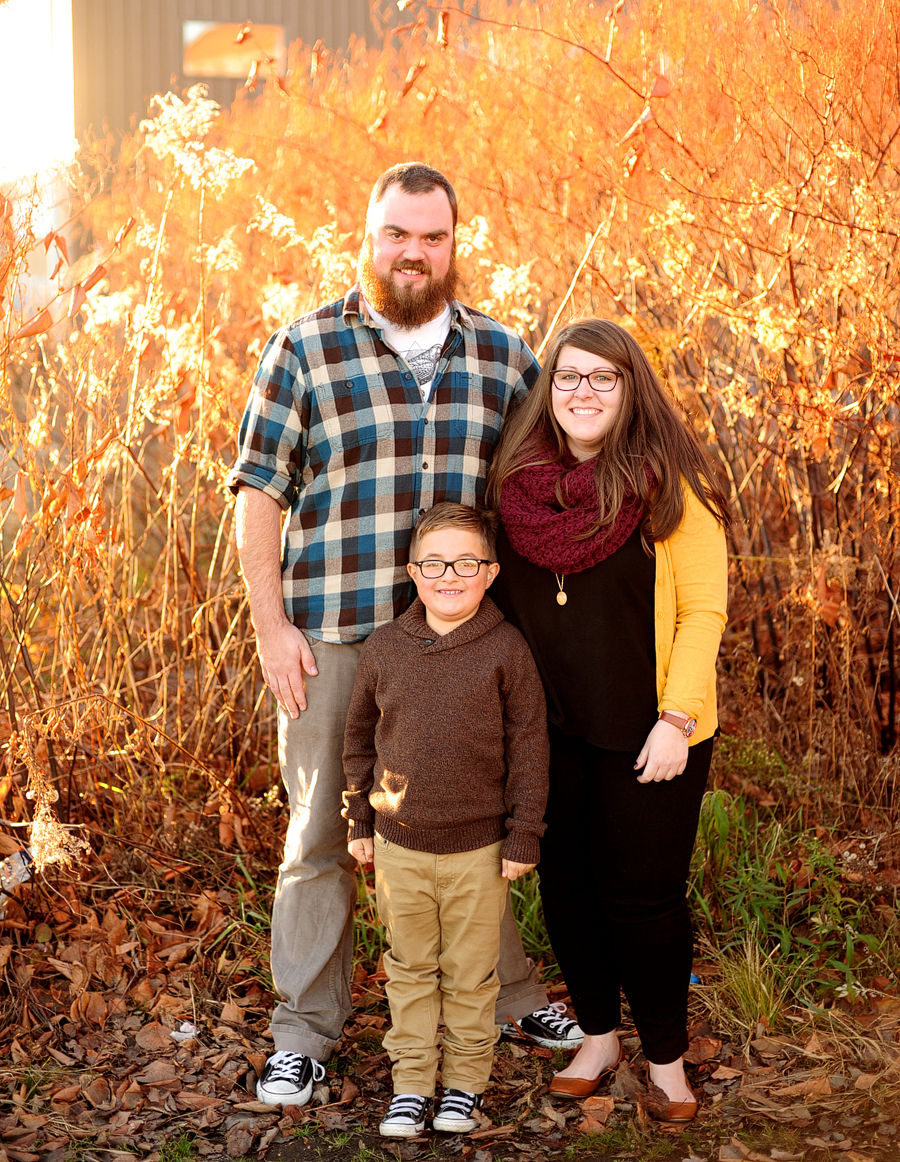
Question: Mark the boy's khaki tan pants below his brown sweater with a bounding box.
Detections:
[375,834,507,1097]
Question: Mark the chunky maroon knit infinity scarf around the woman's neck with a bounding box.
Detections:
[499,449,643,573]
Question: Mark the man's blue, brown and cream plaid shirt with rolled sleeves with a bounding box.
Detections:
[228,287,538,643]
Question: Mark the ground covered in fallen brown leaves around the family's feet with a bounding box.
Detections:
[0,884,900,1162]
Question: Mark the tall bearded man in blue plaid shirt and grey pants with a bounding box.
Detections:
[229,163,583,1105]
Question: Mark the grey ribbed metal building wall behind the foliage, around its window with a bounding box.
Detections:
[72,0,374,137]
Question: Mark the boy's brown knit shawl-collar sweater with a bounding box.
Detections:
[343,597,549,863]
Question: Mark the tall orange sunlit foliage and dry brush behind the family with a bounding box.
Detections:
[0,0,900,836]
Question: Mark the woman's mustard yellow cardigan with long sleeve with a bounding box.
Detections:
[654,483,728,745]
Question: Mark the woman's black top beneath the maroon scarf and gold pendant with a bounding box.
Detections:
[490,526,658,752]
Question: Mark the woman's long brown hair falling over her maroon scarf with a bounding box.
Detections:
[487,318,730,541]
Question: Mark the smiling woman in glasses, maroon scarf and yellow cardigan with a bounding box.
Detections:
[488,320,728,1121]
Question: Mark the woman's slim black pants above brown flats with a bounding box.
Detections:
[539,726,713,1066]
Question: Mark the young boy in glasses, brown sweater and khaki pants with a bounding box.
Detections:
[343,502,548,1138]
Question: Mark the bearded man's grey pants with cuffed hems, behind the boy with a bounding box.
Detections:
[272,640,547,1061]
